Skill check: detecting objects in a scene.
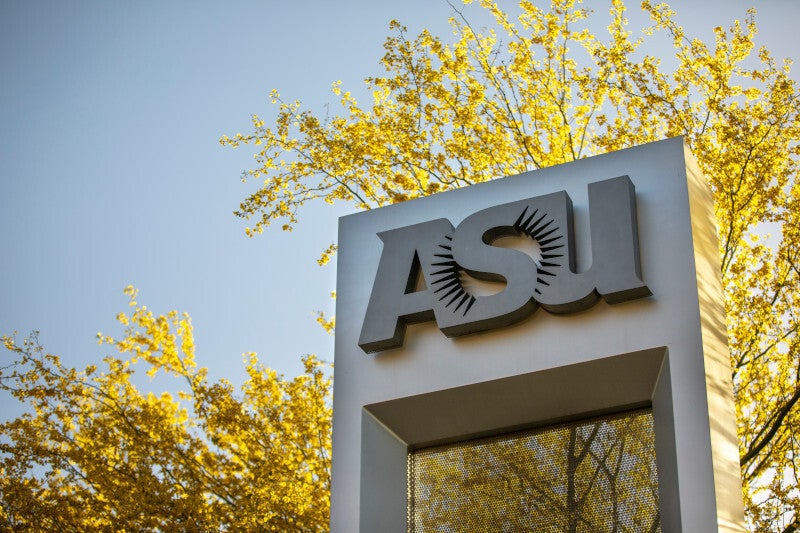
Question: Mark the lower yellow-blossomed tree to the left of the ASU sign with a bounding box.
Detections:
[0,287,331,532]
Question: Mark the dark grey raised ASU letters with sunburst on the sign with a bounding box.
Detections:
[358,172,651,353]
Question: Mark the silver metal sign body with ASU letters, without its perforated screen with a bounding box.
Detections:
[331,139,743,533]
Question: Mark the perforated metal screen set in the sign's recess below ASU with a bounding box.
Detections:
[408,409,661,533]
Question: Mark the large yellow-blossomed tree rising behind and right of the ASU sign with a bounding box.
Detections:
[221,0,800,532]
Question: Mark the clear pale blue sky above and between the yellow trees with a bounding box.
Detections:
[0,0,800,414]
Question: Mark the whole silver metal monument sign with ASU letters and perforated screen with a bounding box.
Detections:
[331,138,744,533]
